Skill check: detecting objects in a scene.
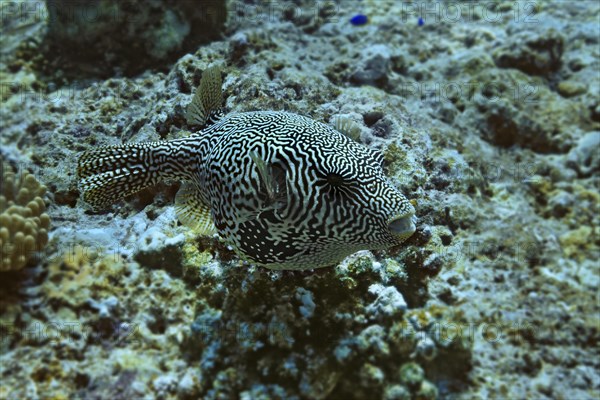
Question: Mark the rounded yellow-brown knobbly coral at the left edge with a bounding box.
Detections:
[0,166,50,271]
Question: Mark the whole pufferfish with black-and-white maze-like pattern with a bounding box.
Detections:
[77,67,416,270]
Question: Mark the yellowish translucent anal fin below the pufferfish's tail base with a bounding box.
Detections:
[175,182,217,236]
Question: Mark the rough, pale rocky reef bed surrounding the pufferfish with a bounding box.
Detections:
[0,0,600,400]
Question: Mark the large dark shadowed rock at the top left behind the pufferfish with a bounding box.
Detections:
[45,0,227,78]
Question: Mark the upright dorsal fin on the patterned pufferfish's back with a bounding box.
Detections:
[185,66,223,126]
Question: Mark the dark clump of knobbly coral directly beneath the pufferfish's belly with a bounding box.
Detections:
[183,252,470,399]
